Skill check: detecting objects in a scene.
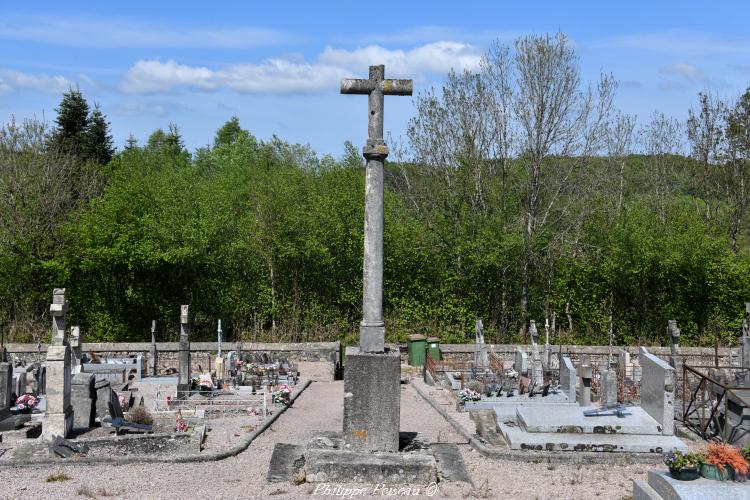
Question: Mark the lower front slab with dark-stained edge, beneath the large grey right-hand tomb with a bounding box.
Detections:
[498,423,687,453]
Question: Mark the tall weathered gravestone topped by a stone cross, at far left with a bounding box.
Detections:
[42,288,73,441]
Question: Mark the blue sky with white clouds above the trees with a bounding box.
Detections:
[0,0,750,156]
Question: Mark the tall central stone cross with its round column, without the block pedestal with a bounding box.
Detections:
[341,65,413,352]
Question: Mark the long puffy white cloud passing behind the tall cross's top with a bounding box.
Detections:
[120,41,481,94]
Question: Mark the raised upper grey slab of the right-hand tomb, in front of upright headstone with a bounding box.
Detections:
[517,406,662,435]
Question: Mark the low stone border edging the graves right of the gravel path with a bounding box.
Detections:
[411,384,662,465]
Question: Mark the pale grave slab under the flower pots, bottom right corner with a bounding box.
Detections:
[644,470,750,500]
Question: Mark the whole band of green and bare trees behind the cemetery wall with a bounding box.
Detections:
[0,34,750,345]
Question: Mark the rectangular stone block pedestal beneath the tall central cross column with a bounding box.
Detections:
[344,347,401,452]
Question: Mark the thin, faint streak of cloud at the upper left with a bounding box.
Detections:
[0,15,299,49]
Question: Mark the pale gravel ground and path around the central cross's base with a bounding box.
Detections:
[0,374,650,499]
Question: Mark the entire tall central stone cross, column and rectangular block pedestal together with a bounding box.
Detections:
[341,65,413,452]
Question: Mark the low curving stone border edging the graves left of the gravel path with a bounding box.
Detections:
[0,380,313,468]
